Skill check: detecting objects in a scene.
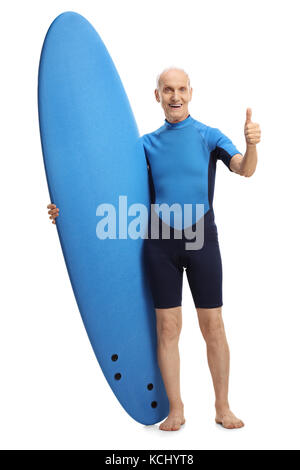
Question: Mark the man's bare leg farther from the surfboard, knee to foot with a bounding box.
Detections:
[196,307,244,429]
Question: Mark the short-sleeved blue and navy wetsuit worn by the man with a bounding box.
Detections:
[142,115,241,308]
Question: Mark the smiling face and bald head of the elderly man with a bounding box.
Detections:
[155,70,193,122]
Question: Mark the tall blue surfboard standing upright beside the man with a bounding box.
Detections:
[38,12,169,424]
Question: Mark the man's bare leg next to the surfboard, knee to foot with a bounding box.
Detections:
[155,307,185,431]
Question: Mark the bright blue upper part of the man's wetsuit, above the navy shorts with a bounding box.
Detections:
[142,115,241,228]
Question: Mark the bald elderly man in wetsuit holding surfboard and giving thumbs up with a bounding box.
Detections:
[47,68,261,431]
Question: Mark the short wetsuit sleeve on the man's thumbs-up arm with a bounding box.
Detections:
[207,127,241,171]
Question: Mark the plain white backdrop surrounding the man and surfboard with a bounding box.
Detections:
[0,0,300,449]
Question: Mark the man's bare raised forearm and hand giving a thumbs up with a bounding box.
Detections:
[230,108,261,177]
